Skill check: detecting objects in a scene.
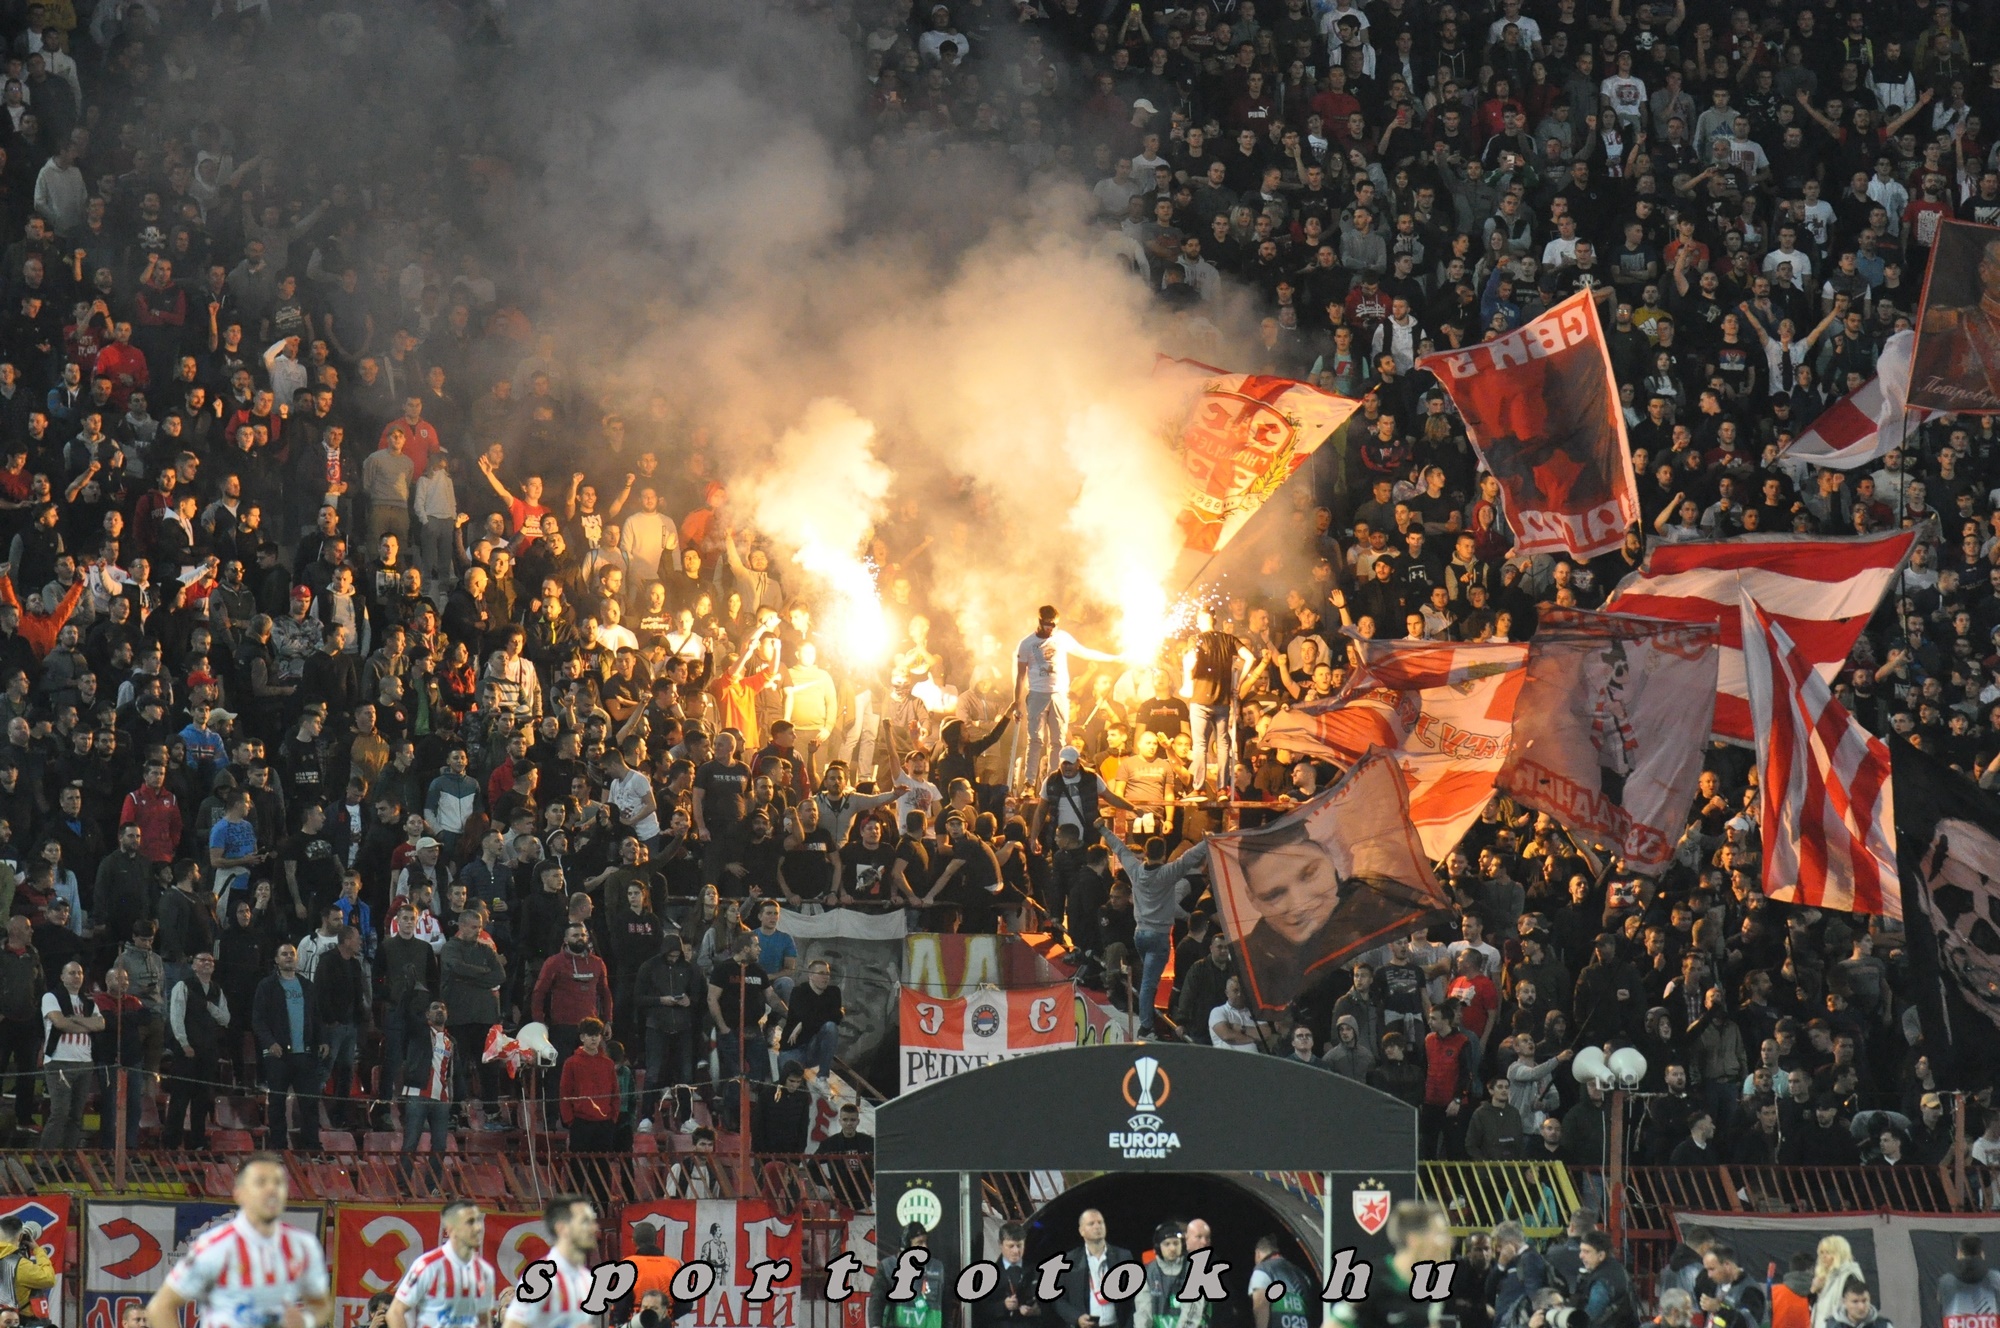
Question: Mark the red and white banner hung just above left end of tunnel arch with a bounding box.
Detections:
[898,982,1076,1092]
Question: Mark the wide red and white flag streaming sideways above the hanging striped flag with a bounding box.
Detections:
[1604,530,1916,746]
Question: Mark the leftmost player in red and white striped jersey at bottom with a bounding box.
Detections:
[146,1152,334,1328]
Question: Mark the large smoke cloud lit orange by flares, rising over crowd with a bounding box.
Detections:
[480,2,1232,680]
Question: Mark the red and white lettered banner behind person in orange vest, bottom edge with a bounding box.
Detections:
[628,1198,804,1328]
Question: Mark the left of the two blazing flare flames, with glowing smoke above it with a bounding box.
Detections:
[742,396,894,664]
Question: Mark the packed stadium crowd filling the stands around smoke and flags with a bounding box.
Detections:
[0,0,2000,1328]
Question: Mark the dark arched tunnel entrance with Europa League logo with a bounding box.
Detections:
[876,1042,1416,1290]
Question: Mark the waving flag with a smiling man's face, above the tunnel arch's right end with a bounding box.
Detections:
[1208,752,1446,1010]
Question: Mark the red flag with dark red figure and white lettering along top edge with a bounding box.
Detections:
[1418,290,1638,558]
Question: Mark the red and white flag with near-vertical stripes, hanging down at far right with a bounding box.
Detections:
[1738,590,1902,918]
